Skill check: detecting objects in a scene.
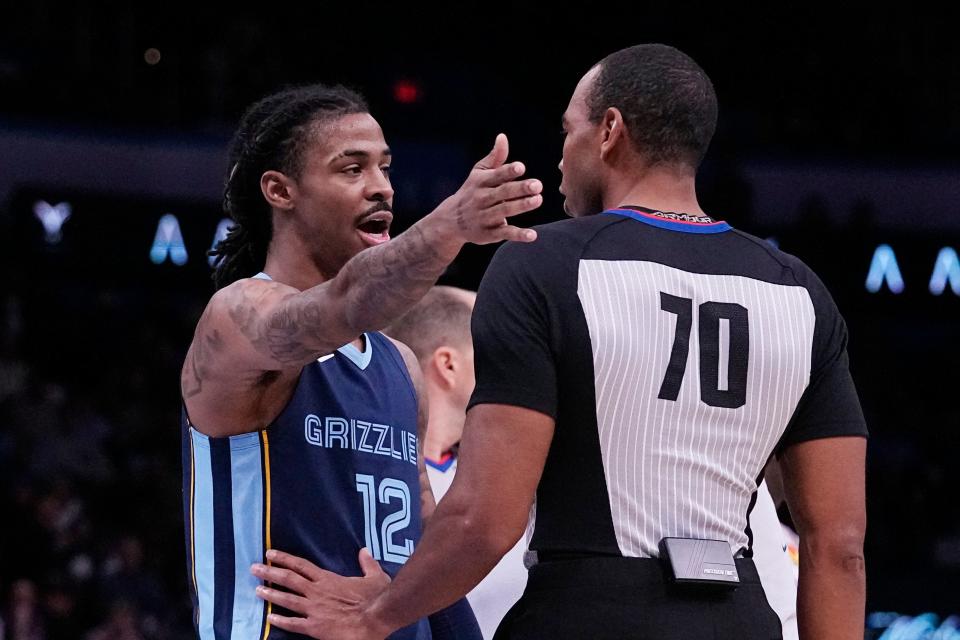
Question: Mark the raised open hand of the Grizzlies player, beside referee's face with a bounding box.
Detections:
[437,133,543,244]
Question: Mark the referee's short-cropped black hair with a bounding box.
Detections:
[587,44,717,169]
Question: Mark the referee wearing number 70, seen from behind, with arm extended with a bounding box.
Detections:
[255,45,867,640]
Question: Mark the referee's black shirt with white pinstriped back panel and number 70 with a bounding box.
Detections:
[471,208,866,557]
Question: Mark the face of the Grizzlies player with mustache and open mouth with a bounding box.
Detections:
[294,113,393,277]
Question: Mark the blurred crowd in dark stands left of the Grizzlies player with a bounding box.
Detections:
[0,288,190,640]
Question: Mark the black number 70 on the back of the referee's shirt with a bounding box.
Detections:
[657,291,750,409]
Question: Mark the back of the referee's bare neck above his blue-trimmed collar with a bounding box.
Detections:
[603,167,706,215]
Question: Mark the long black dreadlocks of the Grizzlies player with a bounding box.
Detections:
[210,84,369,289]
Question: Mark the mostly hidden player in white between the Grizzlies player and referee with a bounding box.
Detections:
[384,287,527,640]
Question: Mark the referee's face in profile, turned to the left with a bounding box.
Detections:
[560,67,603,218]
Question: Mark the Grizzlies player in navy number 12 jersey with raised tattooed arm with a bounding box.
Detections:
[181,85,542,640]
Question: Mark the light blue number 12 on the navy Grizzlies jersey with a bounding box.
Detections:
[357,473,413,564]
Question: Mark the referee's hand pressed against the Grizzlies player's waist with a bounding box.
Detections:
[250,548,391,640]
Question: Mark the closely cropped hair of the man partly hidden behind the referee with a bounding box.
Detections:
[383,286,477,362]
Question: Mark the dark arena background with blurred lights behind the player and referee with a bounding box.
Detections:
[0,5,960,640]
